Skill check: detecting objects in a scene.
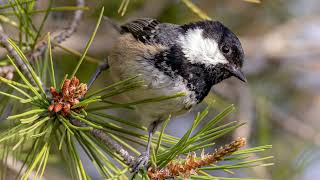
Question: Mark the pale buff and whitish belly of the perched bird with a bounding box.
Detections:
[110,55,196,120]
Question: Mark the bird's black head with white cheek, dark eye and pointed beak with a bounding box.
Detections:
[180,21,247,84]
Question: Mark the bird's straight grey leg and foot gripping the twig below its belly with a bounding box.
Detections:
[132,120,162,173]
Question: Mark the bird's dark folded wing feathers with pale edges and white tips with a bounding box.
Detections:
[121,18,160,43]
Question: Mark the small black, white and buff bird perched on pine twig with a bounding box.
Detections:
[104,18,246,172]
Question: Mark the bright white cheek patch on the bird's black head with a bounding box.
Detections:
[178,29,228,66]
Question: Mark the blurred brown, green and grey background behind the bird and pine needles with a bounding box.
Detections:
[2,0,320,180]
